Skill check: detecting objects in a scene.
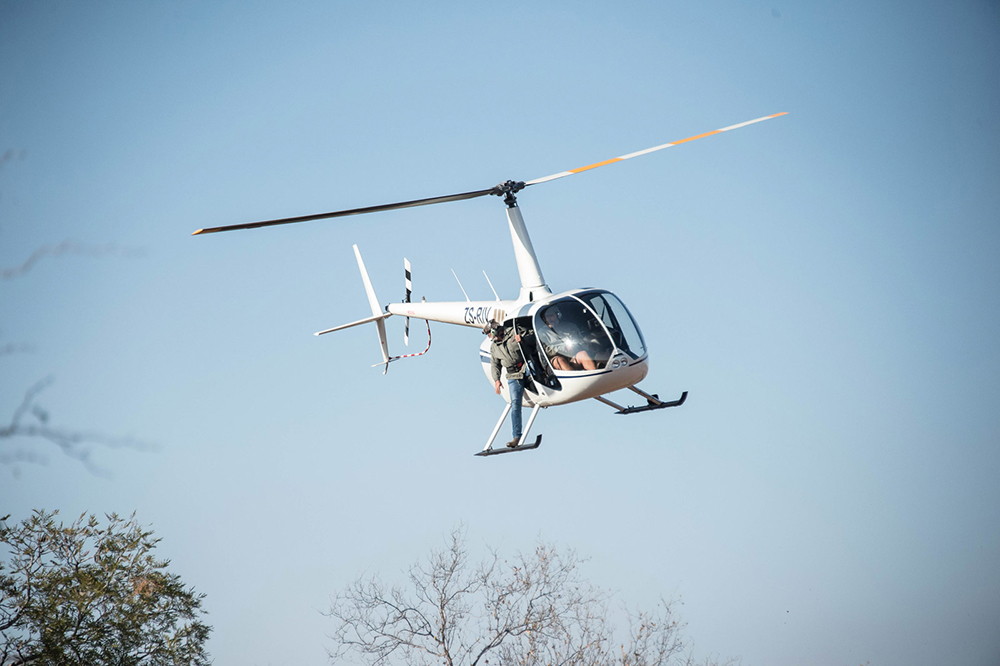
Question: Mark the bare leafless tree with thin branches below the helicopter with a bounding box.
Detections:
[328,530,732,666]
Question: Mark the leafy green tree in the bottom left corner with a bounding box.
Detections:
[0,510,211,666]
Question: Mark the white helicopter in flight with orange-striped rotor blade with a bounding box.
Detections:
[192,112,787,456]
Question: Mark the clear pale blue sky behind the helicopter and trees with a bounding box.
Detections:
[0,0,1000,665]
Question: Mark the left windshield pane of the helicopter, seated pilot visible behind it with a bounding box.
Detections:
[534,298,614,371]
